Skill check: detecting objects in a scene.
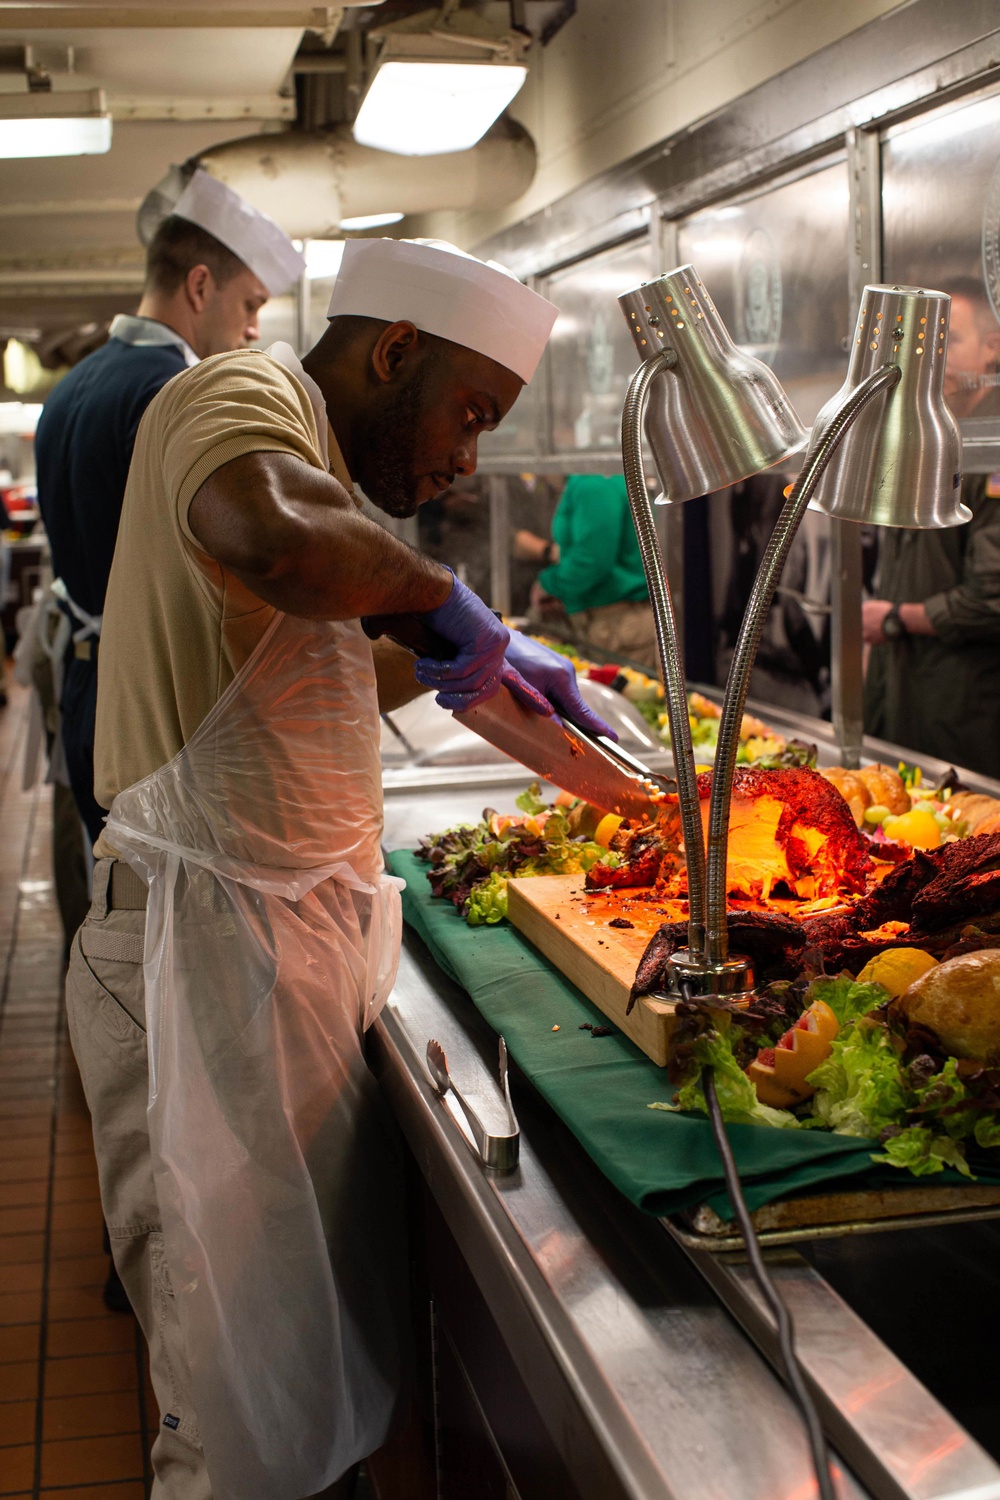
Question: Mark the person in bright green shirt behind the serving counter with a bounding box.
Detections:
[514,474,657,672]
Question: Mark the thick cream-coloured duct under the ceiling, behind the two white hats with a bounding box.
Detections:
[139,117,535,240]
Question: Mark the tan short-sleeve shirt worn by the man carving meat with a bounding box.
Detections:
[94,350,351,854]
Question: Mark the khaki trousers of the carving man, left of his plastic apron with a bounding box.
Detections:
[66,860,211,1500]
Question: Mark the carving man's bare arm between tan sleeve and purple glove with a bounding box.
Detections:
[189,453,451,620]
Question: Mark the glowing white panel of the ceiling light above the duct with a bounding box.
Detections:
[354,62,528,156]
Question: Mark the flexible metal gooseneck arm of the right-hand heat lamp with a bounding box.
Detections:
[705,365,901,968]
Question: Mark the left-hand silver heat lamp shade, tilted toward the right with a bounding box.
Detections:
[618,266,807,504]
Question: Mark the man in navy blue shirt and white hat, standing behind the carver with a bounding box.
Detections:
[36,170,303,843]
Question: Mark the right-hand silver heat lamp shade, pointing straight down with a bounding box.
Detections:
[811,287,972,531]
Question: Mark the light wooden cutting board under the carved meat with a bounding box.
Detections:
[507,875,675,1068]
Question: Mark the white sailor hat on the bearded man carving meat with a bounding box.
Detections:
[327,240,558,383]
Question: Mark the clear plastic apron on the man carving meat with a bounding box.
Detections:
[108,615,402,1500]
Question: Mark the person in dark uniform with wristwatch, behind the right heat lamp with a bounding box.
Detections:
[862,278,1000,777]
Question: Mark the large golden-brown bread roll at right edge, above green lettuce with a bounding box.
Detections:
[889,948,1000,1064]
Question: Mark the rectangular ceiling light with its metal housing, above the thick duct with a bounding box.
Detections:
[354,30,528,156]
